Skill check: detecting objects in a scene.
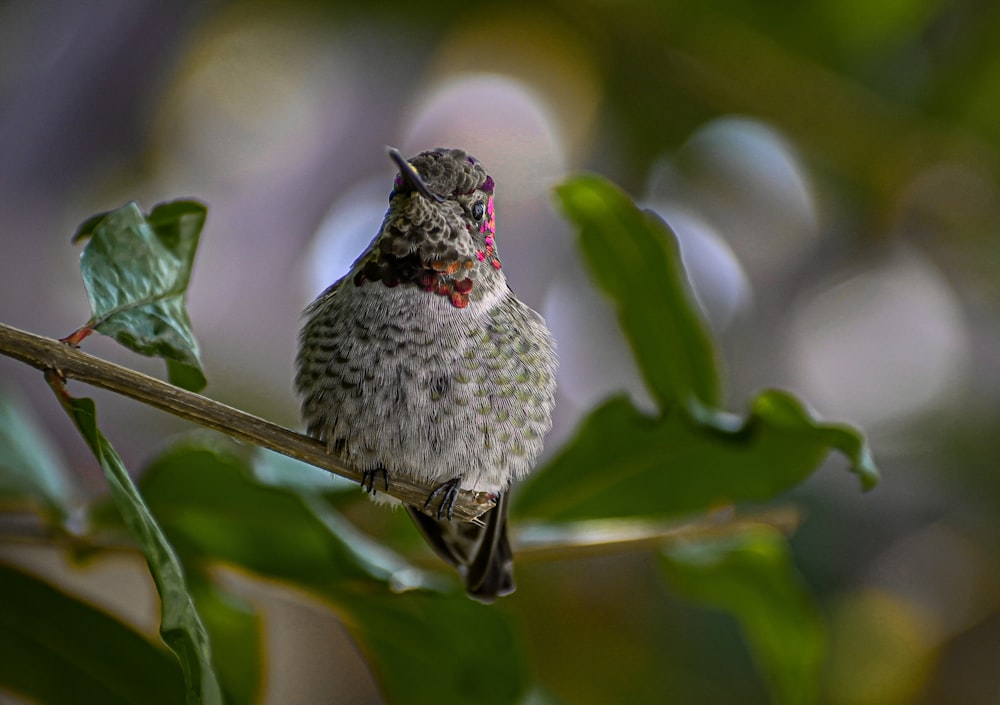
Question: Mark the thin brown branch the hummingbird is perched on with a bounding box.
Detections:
[0,323,494,521]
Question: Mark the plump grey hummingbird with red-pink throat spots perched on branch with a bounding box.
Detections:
[295,148,557,602]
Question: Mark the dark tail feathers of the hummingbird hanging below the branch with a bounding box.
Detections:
[406,494,515,602]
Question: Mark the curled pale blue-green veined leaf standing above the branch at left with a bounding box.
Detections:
[74,201,207,391]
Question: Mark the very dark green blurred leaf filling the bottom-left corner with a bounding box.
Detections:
[0,564,184,705]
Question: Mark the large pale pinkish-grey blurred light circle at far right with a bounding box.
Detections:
[791,249,969,430]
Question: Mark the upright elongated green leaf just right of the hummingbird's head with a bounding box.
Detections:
[556,176,719,410]
